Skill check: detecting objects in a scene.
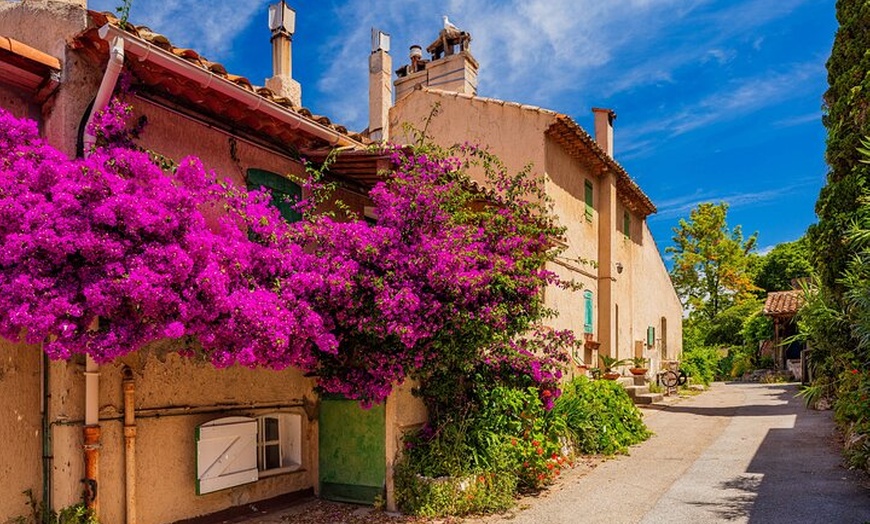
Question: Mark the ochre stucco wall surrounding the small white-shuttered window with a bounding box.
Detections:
[88,352,317,524]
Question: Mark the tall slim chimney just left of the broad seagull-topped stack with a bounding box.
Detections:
[369,28,393,141]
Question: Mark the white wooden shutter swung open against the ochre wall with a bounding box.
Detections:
[196,417,258,495]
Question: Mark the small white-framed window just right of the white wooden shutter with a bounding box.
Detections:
[257,413,302,473]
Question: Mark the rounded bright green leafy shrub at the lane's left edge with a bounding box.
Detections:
[550,377,651,455]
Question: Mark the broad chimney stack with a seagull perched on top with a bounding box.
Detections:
[395,20,480,100]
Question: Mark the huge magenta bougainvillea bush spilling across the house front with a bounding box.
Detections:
[0,100,580,403]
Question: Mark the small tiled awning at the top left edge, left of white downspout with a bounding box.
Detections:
[0,36,61,92]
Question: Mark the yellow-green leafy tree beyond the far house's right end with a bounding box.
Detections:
[665,202,757,320]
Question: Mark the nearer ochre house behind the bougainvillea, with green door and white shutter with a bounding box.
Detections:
[0,0,425,523]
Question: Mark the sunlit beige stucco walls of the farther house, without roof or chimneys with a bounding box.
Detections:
[390,90,682,372]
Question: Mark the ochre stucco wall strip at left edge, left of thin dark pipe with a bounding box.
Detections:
[0,338,42,522]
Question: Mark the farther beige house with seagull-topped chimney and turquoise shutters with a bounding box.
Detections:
[369,27,682,370]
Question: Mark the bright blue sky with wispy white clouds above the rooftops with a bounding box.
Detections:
[89,0,837,251]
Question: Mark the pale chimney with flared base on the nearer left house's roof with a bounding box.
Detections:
[266,0,302,107]
